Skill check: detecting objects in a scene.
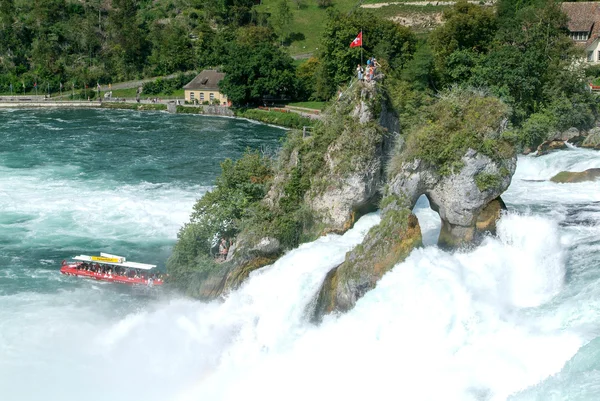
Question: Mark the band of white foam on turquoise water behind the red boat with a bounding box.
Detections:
[0,162,209,246]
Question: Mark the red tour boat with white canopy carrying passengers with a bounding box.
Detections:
[60,252,163,286]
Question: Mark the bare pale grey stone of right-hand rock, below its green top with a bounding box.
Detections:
[389,149,517,247]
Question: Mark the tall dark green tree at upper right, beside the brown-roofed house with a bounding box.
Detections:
[470,2,582,124]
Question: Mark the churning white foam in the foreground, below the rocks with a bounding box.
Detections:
[0,209,583,401]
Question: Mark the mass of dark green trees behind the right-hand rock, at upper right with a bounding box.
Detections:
[398,0,600,148]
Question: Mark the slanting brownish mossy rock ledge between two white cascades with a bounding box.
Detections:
[312,195,421,321]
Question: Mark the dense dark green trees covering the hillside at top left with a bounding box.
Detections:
[0,0,264,88]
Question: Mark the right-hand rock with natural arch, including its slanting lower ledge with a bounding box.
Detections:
[312,88,516,320]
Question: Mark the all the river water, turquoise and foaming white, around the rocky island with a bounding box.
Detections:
[0,110,600,401]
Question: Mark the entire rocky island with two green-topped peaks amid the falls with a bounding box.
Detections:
[168,81,516,318]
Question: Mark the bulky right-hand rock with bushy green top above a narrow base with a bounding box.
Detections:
[388,91,517,247]
